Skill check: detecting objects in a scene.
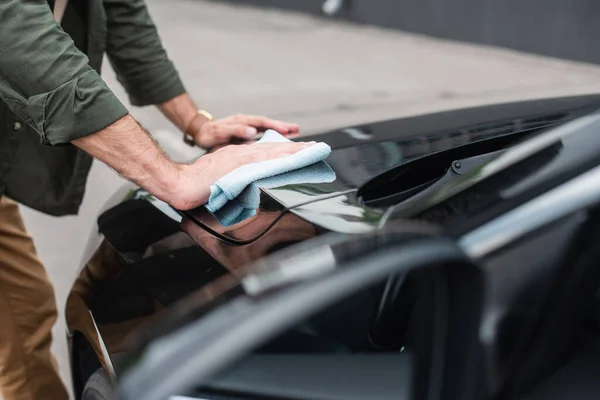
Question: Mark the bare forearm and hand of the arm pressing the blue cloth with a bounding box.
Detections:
[72,115,314,210]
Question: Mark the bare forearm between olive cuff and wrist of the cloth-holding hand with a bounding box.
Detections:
[72,115,181,202]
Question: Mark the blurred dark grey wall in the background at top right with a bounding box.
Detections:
[216,0,600,64]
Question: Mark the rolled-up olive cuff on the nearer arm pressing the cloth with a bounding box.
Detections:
[27,70,129,145]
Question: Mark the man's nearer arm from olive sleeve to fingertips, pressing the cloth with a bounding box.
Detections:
[0,0,308,209]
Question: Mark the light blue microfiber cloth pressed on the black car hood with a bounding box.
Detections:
[205,130,335,226]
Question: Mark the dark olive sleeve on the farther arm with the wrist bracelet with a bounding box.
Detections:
[104,0,185,106]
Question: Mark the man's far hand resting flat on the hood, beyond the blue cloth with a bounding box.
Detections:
[186,114,299,149]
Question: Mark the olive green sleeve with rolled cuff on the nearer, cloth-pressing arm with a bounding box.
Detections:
[0,0,128,145]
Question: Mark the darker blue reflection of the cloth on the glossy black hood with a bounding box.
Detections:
[212,161,336,226]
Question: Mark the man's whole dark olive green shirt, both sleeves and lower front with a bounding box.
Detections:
[0,0,185,215]
